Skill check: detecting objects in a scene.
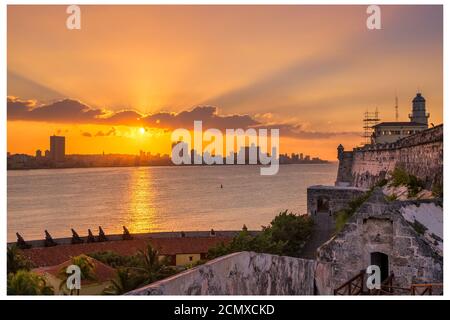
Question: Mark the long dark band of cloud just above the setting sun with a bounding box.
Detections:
[7,97,358,139]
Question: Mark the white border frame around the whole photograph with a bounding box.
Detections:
[0,0,450,301]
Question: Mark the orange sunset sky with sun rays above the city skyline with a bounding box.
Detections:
[7,6,443,160]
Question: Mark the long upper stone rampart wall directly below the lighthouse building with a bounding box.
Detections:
[336,125,443,188]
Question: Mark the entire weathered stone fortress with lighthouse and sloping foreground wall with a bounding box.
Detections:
[129,93,443,295]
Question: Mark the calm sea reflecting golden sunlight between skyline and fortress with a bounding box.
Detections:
[8,163,337,241]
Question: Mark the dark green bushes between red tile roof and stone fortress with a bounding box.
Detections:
[208,210,313,259]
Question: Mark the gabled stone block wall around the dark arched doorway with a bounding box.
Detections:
[315,195,443,294]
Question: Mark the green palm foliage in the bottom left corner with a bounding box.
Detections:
[7,270,54,295]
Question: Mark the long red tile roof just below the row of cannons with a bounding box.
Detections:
[22,237,231,267]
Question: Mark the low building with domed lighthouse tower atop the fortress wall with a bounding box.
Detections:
[372,92,430,144]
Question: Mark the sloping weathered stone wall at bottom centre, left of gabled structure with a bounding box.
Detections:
[128,252,316,295]
